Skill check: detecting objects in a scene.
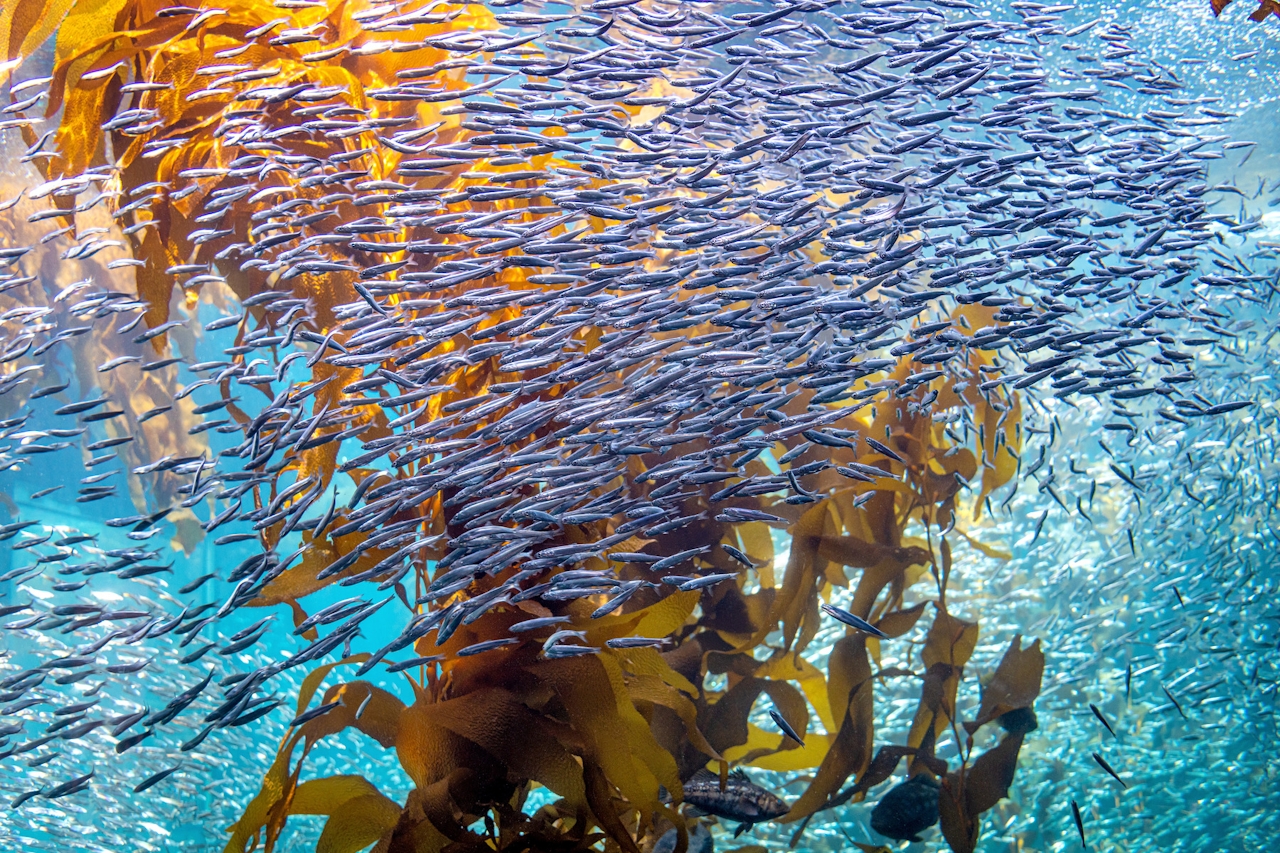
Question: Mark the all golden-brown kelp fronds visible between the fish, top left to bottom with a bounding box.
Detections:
[0,0,1043,853]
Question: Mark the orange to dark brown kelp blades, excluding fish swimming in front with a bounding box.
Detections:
[5,0,1043,853]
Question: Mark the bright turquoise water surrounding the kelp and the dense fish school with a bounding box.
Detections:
[0,0,1280,853]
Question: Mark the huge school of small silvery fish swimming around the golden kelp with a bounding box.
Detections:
[0,0,1280,853]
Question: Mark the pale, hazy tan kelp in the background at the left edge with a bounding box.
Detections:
[0,179,209,512]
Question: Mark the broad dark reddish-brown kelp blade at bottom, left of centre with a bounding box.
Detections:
[420,688,585,807]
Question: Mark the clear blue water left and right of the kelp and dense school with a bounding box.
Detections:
[0,0,1280,853]
